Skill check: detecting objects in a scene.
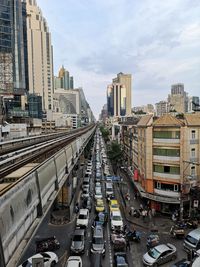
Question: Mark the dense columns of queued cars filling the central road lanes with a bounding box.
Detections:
[66,131,130,267]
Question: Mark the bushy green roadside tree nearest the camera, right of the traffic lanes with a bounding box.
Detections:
[107,141,123,173]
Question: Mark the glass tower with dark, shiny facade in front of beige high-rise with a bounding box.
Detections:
[107,83,127,117]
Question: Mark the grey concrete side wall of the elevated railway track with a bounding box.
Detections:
[0,130,93,263]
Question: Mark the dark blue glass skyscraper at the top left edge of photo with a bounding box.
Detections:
[0,0,26,95]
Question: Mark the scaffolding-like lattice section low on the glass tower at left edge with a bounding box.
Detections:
[0,52,13,95]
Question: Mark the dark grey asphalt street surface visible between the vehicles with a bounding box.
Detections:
[17,132,191,267]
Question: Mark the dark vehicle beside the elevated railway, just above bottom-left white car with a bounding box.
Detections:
[35,236,60,253]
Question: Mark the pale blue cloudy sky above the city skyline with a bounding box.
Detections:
[37,0,200,118]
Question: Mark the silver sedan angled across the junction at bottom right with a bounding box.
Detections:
[143,243,177,267]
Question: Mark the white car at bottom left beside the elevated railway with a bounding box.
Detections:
[18,251,58,267]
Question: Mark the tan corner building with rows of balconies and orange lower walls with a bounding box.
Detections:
[122,113,200,216]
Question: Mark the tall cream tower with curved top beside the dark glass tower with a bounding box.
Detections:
[26,0,53,112]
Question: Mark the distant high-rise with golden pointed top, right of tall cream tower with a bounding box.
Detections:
[54,66,74,90]
